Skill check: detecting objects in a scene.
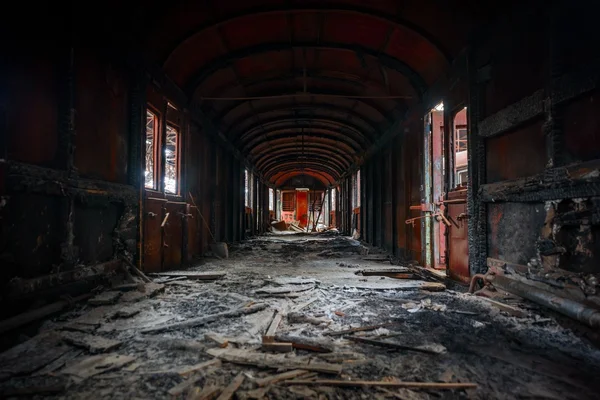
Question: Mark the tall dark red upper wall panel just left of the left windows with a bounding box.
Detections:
[75,49,130,183]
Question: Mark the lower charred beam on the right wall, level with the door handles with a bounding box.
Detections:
[479,160,600,203]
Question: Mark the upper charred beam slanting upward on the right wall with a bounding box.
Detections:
[478,56,600,138]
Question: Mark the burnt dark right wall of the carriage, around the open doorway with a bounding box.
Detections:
[360,1,600,273]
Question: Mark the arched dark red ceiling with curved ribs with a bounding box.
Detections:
[138,0,504,185]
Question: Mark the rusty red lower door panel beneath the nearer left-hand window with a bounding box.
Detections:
[143,198,165,272]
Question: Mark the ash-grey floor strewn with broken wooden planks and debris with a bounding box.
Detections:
[0,235,600,399]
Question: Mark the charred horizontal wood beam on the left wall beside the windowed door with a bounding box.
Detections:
[6,161,138,207]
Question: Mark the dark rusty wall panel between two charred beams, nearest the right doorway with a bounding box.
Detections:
[486,120,548,183]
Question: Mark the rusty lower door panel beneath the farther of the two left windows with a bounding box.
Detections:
[162,201,186,271]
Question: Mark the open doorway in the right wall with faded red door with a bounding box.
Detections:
[418,103,470,282]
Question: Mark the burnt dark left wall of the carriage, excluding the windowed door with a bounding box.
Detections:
[0,14,268,311]
